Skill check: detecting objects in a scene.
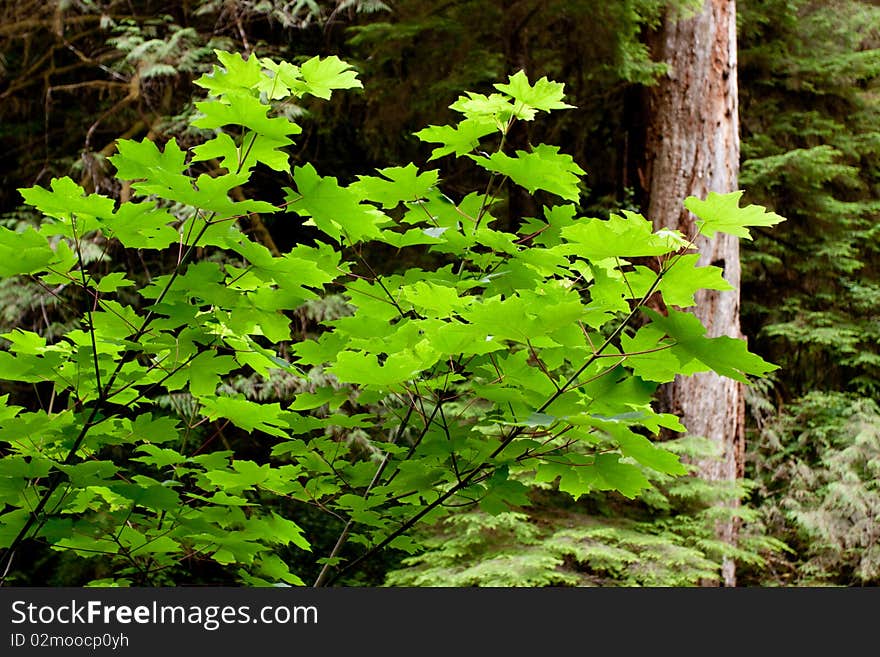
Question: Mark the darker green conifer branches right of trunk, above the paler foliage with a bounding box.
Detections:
[741,0,880,399]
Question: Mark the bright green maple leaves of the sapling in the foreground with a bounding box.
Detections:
[0,53,773,585]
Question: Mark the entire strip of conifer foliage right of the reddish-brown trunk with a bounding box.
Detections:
[739,0,880,586]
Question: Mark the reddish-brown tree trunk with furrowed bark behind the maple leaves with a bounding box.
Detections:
[645,0,745,586]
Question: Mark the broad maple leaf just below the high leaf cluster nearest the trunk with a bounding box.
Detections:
[469,144,586,201]
